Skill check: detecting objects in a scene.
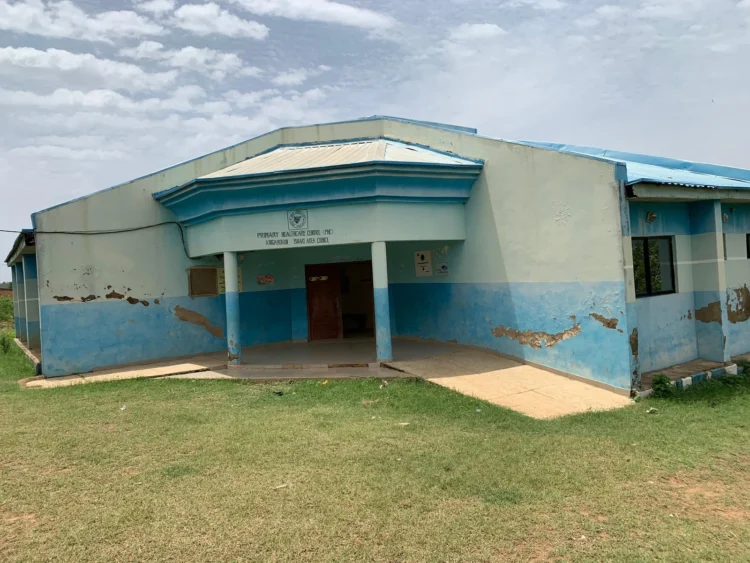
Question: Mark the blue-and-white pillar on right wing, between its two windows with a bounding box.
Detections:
[690,200,729,362]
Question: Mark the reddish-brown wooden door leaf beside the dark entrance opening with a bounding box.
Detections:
[305,264,344,340]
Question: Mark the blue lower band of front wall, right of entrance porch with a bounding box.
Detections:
[391,282,632,389]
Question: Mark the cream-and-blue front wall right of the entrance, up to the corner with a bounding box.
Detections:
[385,121,631,389]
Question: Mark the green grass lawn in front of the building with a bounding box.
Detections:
[0,349,750,561]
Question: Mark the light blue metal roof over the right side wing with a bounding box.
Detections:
[519,141,750,190]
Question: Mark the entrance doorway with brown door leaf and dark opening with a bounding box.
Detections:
[305,261,375,340]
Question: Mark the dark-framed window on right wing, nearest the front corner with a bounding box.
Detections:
[633,237,675,297]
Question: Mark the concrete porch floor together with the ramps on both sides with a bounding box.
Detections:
[21,343,632,419]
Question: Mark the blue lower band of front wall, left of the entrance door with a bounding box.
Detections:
[41,290,300,377]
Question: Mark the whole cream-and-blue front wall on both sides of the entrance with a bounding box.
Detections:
[35,114,631,389]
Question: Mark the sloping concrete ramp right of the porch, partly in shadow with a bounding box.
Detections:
[388,349,632,419]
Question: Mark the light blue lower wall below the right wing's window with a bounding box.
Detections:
[635,292,698,373]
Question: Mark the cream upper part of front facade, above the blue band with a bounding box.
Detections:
[35,115,624,305]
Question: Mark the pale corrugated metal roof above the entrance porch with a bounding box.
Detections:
[201,139,477,179]
